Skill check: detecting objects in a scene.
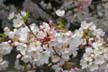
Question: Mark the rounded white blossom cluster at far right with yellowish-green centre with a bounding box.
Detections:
[78,22,108,71]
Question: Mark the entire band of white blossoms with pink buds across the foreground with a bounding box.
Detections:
[0,11,108,72]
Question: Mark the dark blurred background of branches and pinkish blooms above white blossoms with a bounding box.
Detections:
[0,0,108,32]
